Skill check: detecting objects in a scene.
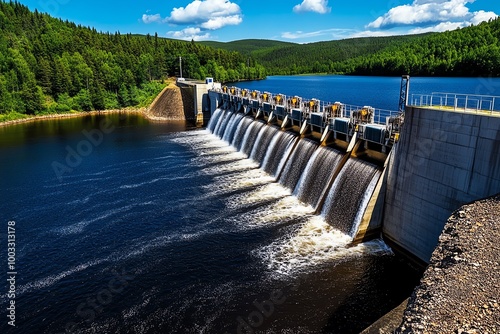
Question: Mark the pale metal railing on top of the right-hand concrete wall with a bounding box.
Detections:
[409,92,500,114]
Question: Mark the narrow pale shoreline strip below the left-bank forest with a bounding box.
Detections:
[0,107,181,128]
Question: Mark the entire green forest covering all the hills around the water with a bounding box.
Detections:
[0,0,500,121]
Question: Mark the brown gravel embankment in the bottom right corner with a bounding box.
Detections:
[396,195,500,334]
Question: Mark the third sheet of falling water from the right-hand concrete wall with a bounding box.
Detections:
[279,138,318,190]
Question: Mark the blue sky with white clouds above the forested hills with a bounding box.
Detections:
[20,0,500,43]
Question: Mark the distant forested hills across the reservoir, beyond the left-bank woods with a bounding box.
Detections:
[203,19,500,76]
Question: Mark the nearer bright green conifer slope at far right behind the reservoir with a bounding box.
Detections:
[333,18,500,77]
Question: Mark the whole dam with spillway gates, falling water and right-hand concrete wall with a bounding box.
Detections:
[198,76,500,265]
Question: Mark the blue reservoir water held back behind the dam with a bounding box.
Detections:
[228,75,500,111]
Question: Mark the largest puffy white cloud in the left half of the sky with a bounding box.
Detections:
[166,0,243,29]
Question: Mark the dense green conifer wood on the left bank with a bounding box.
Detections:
[0,1,265,114]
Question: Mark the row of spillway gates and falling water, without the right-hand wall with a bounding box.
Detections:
[203,87,402,252]
